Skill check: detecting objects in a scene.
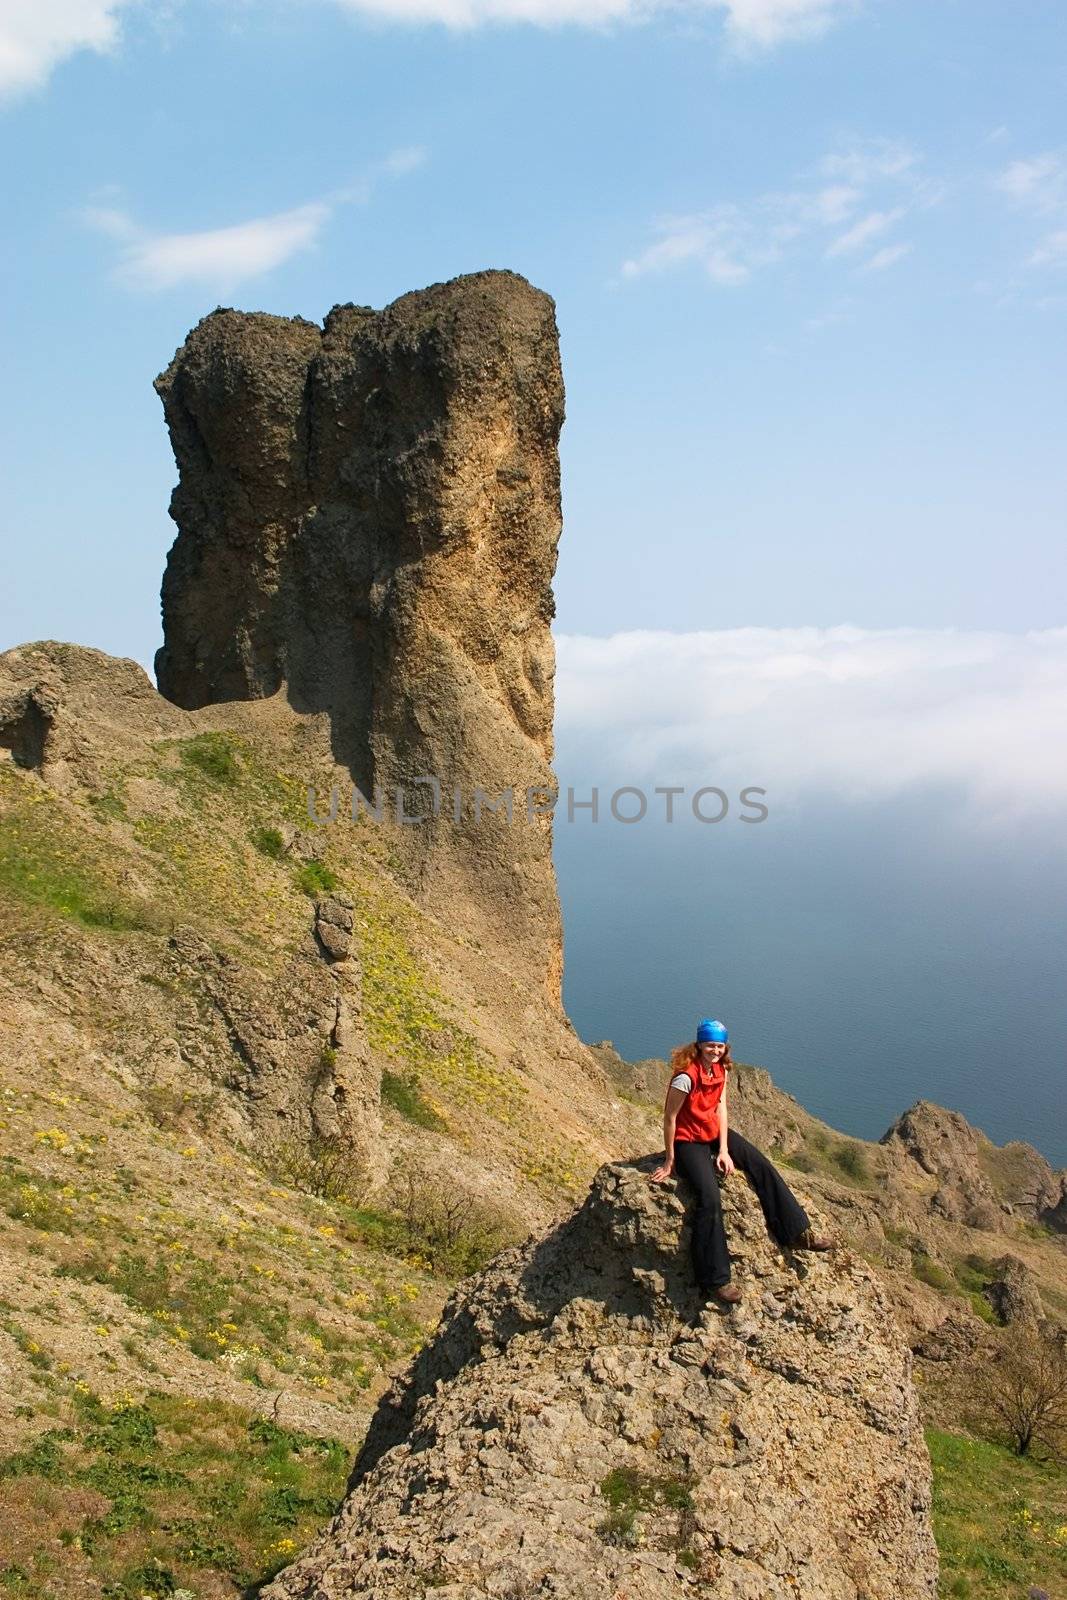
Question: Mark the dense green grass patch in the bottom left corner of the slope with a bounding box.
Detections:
[0,1384,349,1600]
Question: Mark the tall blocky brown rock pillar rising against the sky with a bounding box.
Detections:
[156,272,563,1002]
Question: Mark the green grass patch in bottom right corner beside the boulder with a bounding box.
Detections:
[926,1429,1067,1600]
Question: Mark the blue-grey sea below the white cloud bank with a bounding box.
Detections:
[553,780,1067,1166]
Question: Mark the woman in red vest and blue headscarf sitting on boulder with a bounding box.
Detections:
[651,1018,833,1302]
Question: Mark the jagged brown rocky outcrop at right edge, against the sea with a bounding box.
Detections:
[881,1101,1067,1232]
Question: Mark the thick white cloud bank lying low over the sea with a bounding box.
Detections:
[555,626,1067,843]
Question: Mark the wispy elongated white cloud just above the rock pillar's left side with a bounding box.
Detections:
[82,147,426,290]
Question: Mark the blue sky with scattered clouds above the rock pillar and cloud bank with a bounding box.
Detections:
[0,0,1067,664]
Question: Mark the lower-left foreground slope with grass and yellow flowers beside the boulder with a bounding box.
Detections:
[0,1011,448,1600]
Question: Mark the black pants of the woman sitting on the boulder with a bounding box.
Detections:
[675,1128,809,1290]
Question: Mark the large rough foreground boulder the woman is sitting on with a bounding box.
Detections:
[266,1160,936,1600]
